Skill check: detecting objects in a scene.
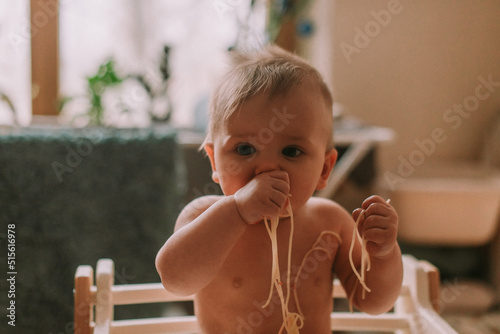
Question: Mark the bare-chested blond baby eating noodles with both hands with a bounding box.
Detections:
[156,47,402,334]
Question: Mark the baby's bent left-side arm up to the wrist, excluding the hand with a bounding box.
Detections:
[156,196,247,295]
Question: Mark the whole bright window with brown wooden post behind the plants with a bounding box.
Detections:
[0,0,266,127]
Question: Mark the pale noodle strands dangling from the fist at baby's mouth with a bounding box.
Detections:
[262,204,304,334]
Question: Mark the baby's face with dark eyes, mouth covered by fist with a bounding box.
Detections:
[209,82,336,209]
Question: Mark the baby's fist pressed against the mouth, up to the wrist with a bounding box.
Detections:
[234,170,290,224]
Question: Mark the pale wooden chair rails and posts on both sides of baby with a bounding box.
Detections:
[74,255,457,334]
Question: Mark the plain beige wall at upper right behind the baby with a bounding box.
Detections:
[306,0,500,177]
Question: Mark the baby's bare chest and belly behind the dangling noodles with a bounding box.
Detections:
[195,223,339,333]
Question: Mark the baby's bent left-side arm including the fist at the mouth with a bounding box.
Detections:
[156,171,289,295]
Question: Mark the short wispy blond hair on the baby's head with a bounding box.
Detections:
[201,46,333,148]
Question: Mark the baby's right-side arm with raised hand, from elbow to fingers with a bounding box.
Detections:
[336,196,403,314]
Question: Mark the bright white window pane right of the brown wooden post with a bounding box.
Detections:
[59,0,265,127]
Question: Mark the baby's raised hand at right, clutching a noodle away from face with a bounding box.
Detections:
[352,196,398,257]
